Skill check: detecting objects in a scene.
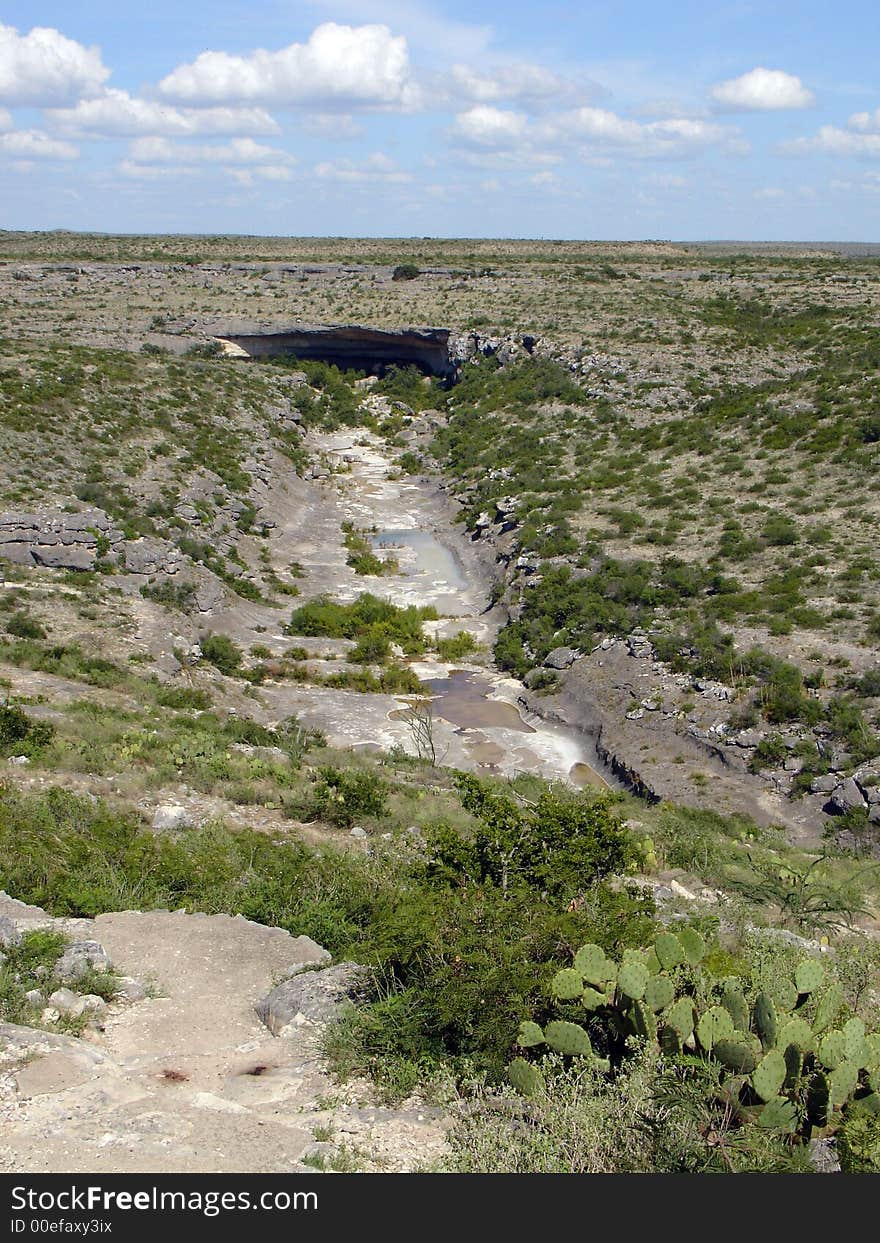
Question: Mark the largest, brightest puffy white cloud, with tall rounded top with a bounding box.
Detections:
[159,21,418,108]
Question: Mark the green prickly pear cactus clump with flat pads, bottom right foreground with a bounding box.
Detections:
[510,929,880,1142]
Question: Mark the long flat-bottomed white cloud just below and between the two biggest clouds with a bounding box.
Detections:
[47,88,281,138]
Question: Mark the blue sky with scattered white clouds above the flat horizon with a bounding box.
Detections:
[0,0,880,242]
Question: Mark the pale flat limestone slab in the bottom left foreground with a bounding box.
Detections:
[0,899,445,1173]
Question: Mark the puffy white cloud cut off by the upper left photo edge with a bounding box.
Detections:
[0,24,111,107]
